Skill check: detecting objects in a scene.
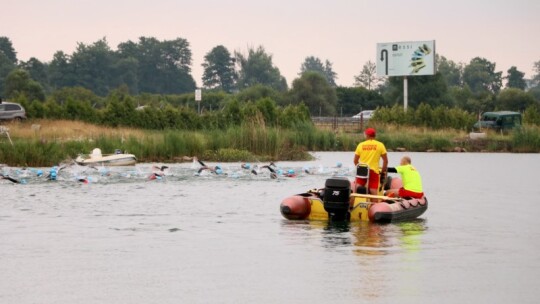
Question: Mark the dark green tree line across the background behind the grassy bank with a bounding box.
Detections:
[0,37,540,128]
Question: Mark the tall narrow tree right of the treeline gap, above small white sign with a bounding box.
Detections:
[202,45,238,93]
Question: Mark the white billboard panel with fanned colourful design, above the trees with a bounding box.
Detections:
[377,40,435,76]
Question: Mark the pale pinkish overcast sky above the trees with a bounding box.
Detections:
[4,0,540,86]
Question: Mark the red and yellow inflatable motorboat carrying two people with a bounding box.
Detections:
[280,177,428,222]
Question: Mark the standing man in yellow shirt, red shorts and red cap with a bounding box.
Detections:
[354,128,388,195]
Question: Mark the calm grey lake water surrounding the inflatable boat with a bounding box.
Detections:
[0,152,540,304]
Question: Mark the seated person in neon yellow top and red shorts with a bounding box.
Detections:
[385,156,424,198]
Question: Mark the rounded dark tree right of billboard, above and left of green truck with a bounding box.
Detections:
[463,57,502,94]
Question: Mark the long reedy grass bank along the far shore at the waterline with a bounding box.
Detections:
[0,120,540,166]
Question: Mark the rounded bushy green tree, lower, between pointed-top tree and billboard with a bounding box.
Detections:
[289,72,337,116]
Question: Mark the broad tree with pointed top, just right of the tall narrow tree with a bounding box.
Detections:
[235,46,287,92]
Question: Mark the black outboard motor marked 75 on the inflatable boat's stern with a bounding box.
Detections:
[323,177,351,221]
